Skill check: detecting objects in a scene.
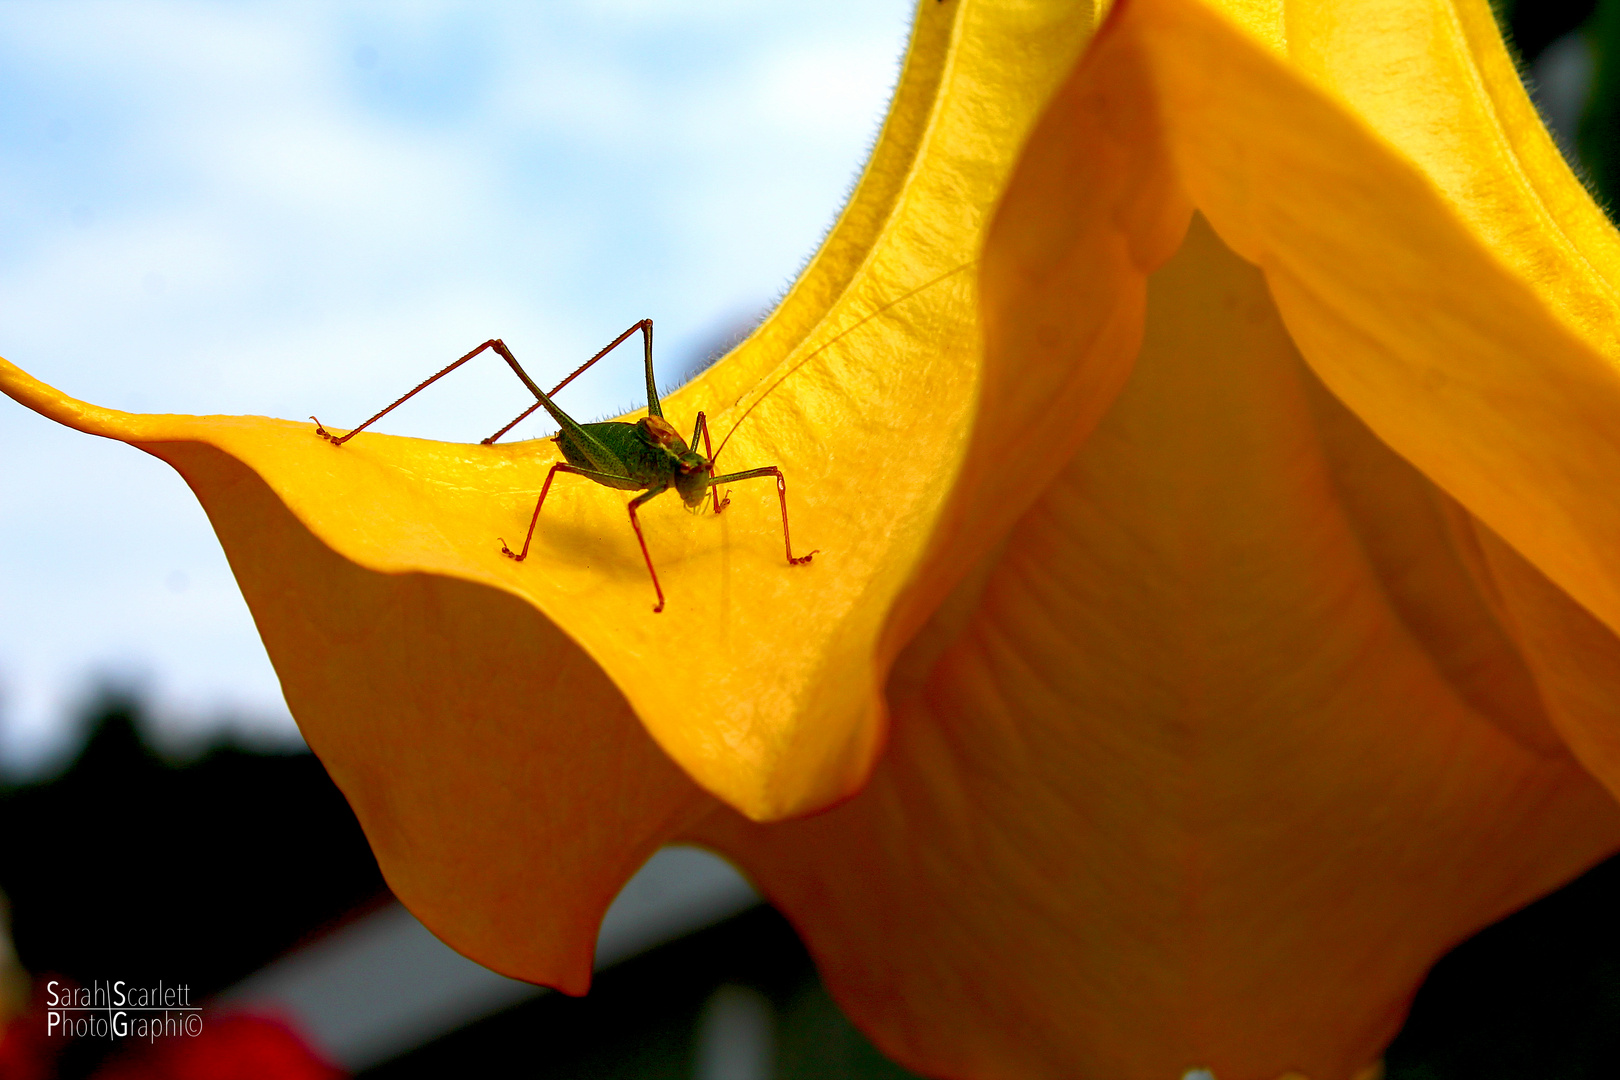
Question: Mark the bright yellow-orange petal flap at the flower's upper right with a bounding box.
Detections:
[1100,0,1620,792]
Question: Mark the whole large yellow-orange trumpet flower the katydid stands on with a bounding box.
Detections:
[0,0,1620,1080]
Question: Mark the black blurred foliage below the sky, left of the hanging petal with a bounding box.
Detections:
[0,695,387,1080]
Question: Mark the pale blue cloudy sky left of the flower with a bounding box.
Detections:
[0,0,910,771]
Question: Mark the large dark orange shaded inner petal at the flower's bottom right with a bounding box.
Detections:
[695,215,1620,1080]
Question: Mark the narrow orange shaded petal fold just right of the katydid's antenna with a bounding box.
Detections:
[913,0,1192,651]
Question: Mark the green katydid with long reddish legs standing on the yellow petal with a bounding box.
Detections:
[309,319,816,612]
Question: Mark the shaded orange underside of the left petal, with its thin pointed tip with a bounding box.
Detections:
[0,361,713,993]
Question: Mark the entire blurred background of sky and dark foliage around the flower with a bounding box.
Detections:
[0,0,1620,1080]
